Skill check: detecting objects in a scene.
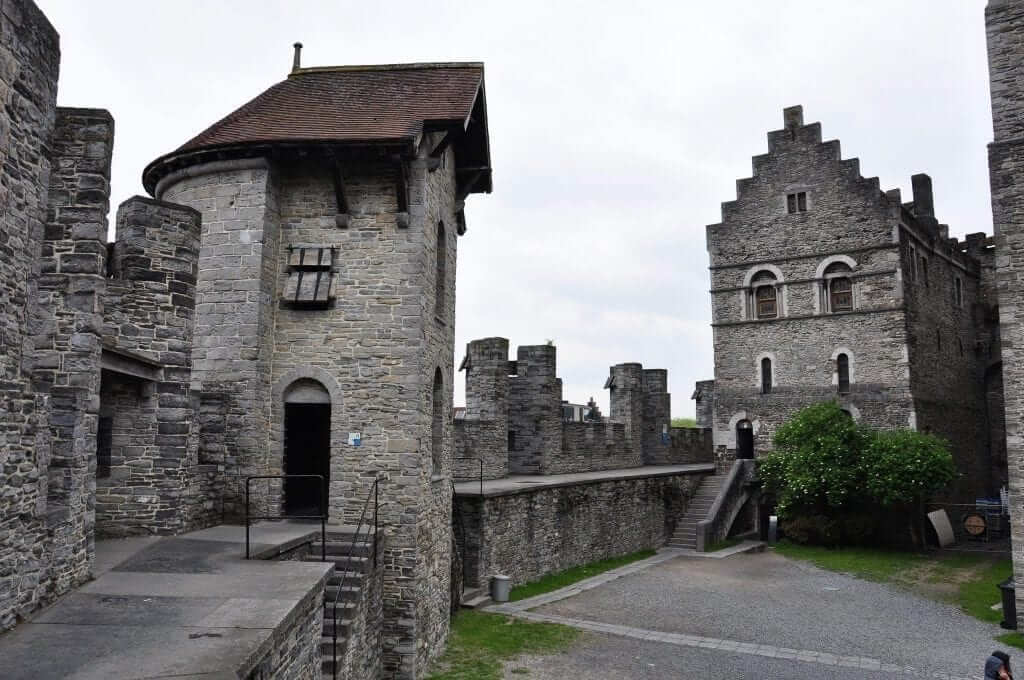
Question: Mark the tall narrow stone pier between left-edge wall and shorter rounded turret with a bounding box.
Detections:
[33,108,114,606]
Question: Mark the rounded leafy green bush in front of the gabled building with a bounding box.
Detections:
[758,401,955,545]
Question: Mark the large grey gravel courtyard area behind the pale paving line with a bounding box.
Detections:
[535,552,1002,677]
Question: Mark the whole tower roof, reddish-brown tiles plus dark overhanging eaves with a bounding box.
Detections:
[142,62,490,193]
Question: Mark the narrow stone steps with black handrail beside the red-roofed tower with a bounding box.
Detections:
[303,532,373,678]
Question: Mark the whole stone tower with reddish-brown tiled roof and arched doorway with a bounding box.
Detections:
[143,59,490,678]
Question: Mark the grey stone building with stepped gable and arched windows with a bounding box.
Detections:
[694,107,1006,499]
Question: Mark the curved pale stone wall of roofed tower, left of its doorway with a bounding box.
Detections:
[157,160,280,518]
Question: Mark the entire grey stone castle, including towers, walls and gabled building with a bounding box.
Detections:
[0,0,1024,678]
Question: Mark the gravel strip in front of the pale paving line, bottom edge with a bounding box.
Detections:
[504,633,905,680]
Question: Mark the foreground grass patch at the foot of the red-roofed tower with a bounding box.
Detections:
[428,610,580,680]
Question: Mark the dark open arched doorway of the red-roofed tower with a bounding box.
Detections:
[285,378,331,515]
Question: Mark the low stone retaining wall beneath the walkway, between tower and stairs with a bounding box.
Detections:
[457,474,701,587]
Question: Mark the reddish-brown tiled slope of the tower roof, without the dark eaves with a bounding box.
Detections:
[177,63,483,152]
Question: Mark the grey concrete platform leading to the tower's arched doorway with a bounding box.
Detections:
[0,522,334,680]
